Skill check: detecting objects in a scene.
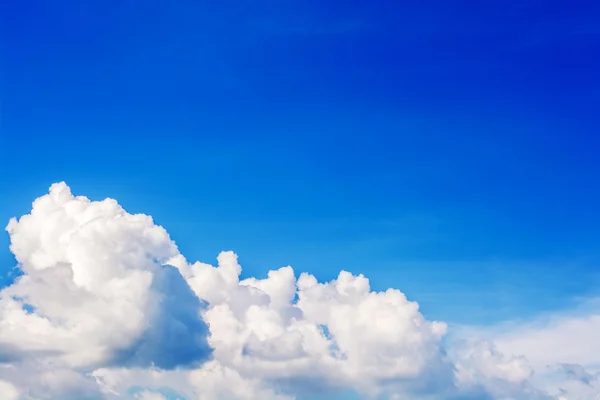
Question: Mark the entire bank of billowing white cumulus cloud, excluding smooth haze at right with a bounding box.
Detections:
[0,183,594,400]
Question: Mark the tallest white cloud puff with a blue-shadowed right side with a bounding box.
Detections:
[0,183,210,368]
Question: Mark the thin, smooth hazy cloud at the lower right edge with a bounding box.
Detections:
[462,299,600,400]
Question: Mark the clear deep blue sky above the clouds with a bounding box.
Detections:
[0,0,600,323]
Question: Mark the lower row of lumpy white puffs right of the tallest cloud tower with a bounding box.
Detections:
[166,252,452,395]
